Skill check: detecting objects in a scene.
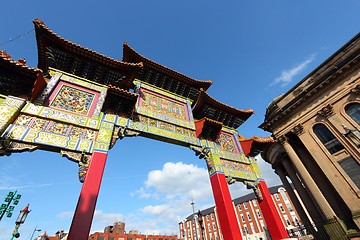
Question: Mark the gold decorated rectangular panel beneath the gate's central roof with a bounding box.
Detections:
[141,91,188,121]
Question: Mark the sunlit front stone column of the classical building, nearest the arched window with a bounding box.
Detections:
[279,136,336,220]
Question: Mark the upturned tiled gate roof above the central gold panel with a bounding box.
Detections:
[123,43,212,99]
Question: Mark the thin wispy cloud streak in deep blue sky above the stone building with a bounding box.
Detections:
[270,54,316,87]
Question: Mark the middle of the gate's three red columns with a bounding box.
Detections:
[210,172,242,240]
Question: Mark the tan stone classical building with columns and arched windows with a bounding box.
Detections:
[260,34,360,237]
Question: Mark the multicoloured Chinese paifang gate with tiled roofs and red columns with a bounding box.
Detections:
[0,19,288,240]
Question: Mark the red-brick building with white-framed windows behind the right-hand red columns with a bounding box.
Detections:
[179,186,301,240]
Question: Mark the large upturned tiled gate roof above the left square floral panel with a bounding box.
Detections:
[33,19,142,89]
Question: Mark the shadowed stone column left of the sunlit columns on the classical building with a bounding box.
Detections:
[275,165,311,225]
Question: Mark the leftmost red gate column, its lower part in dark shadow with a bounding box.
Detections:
[67,152,107,240]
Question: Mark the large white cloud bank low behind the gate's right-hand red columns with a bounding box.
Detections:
[92,156,280,234]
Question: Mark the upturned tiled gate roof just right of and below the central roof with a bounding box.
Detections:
[193,89,254,129]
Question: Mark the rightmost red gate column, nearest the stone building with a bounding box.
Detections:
[258,180,289,240]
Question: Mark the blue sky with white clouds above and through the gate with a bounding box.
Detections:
[0,0,360,239]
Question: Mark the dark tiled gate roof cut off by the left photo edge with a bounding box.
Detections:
[0,50,42,97]
